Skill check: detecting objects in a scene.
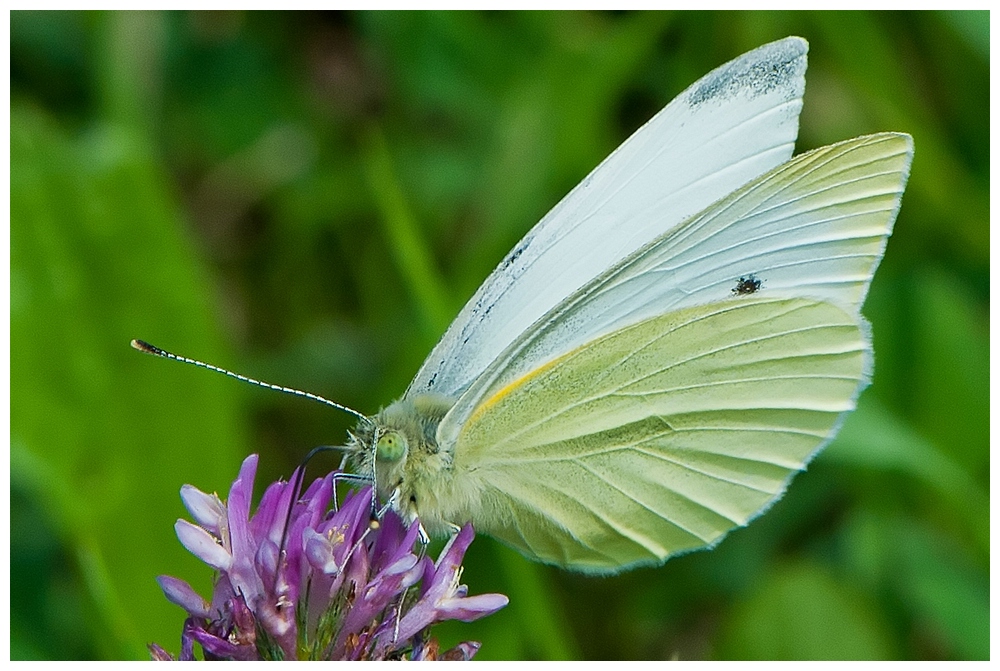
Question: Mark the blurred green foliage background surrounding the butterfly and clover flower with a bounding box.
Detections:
[10,12,989,659]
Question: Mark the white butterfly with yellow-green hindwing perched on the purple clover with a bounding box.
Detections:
[351,37,912,573]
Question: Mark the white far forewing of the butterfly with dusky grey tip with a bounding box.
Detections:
[406,38,807,398]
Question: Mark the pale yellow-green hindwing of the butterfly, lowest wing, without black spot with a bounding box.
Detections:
[455,297,870,572]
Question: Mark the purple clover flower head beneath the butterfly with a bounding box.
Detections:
[149,455,507,660]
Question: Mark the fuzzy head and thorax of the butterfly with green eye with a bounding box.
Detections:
[351,394,465,536]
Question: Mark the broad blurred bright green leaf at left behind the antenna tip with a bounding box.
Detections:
[10,101,245,658]
